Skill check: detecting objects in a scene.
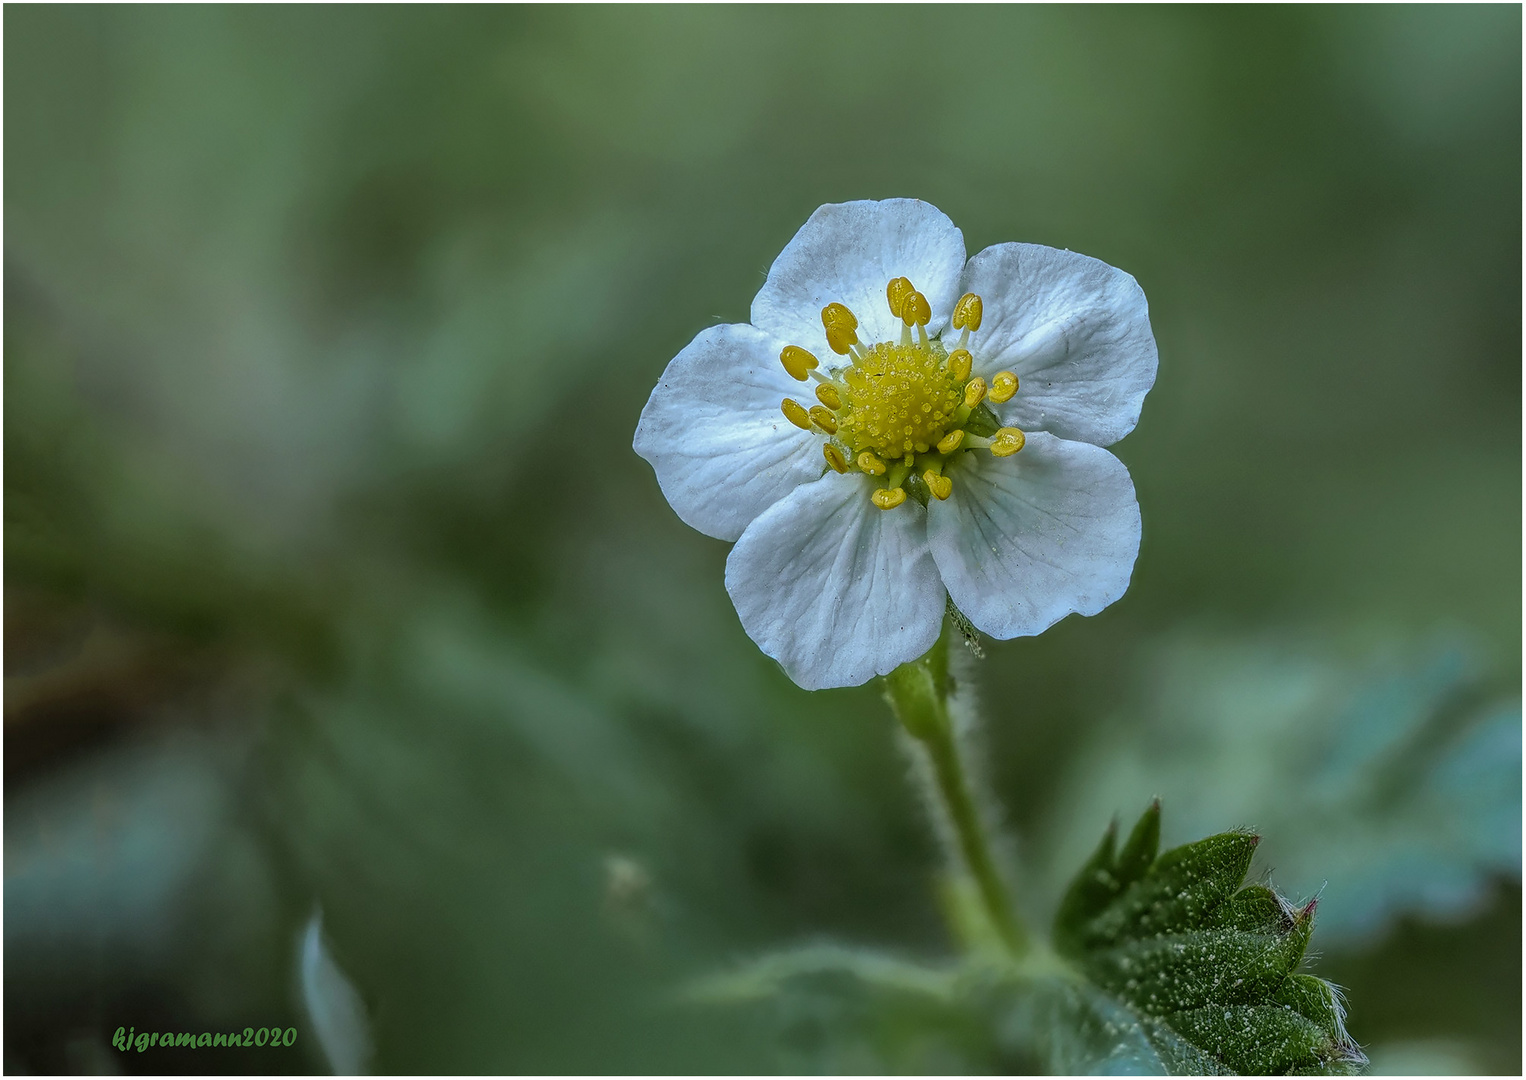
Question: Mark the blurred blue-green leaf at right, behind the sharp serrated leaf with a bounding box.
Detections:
[1036,636,1521,949]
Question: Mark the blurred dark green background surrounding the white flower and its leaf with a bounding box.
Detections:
[5,6,1521,1072]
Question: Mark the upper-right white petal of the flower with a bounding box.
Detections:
[963,244,1158,447]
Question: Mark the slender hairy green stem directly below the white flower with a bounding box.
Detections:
[885,628,1029,956]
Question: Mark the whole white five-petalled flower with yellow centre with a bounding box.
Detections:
[635,198,1157,689]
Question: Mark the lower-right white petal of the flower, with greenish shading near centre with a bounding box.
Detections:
[928,432,1140,638]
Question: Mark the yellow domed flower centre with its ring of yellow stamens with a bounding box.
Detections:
[778,278,1025,509]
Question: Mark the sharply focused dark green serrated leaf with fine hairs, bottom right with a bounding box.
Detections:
[1049,802,1366,1075]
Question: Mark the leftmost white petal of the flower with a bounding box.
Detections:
[635,323,827,540]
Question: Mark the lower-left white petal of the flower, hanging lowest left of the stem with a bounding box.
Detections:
[726,473,945,689]
